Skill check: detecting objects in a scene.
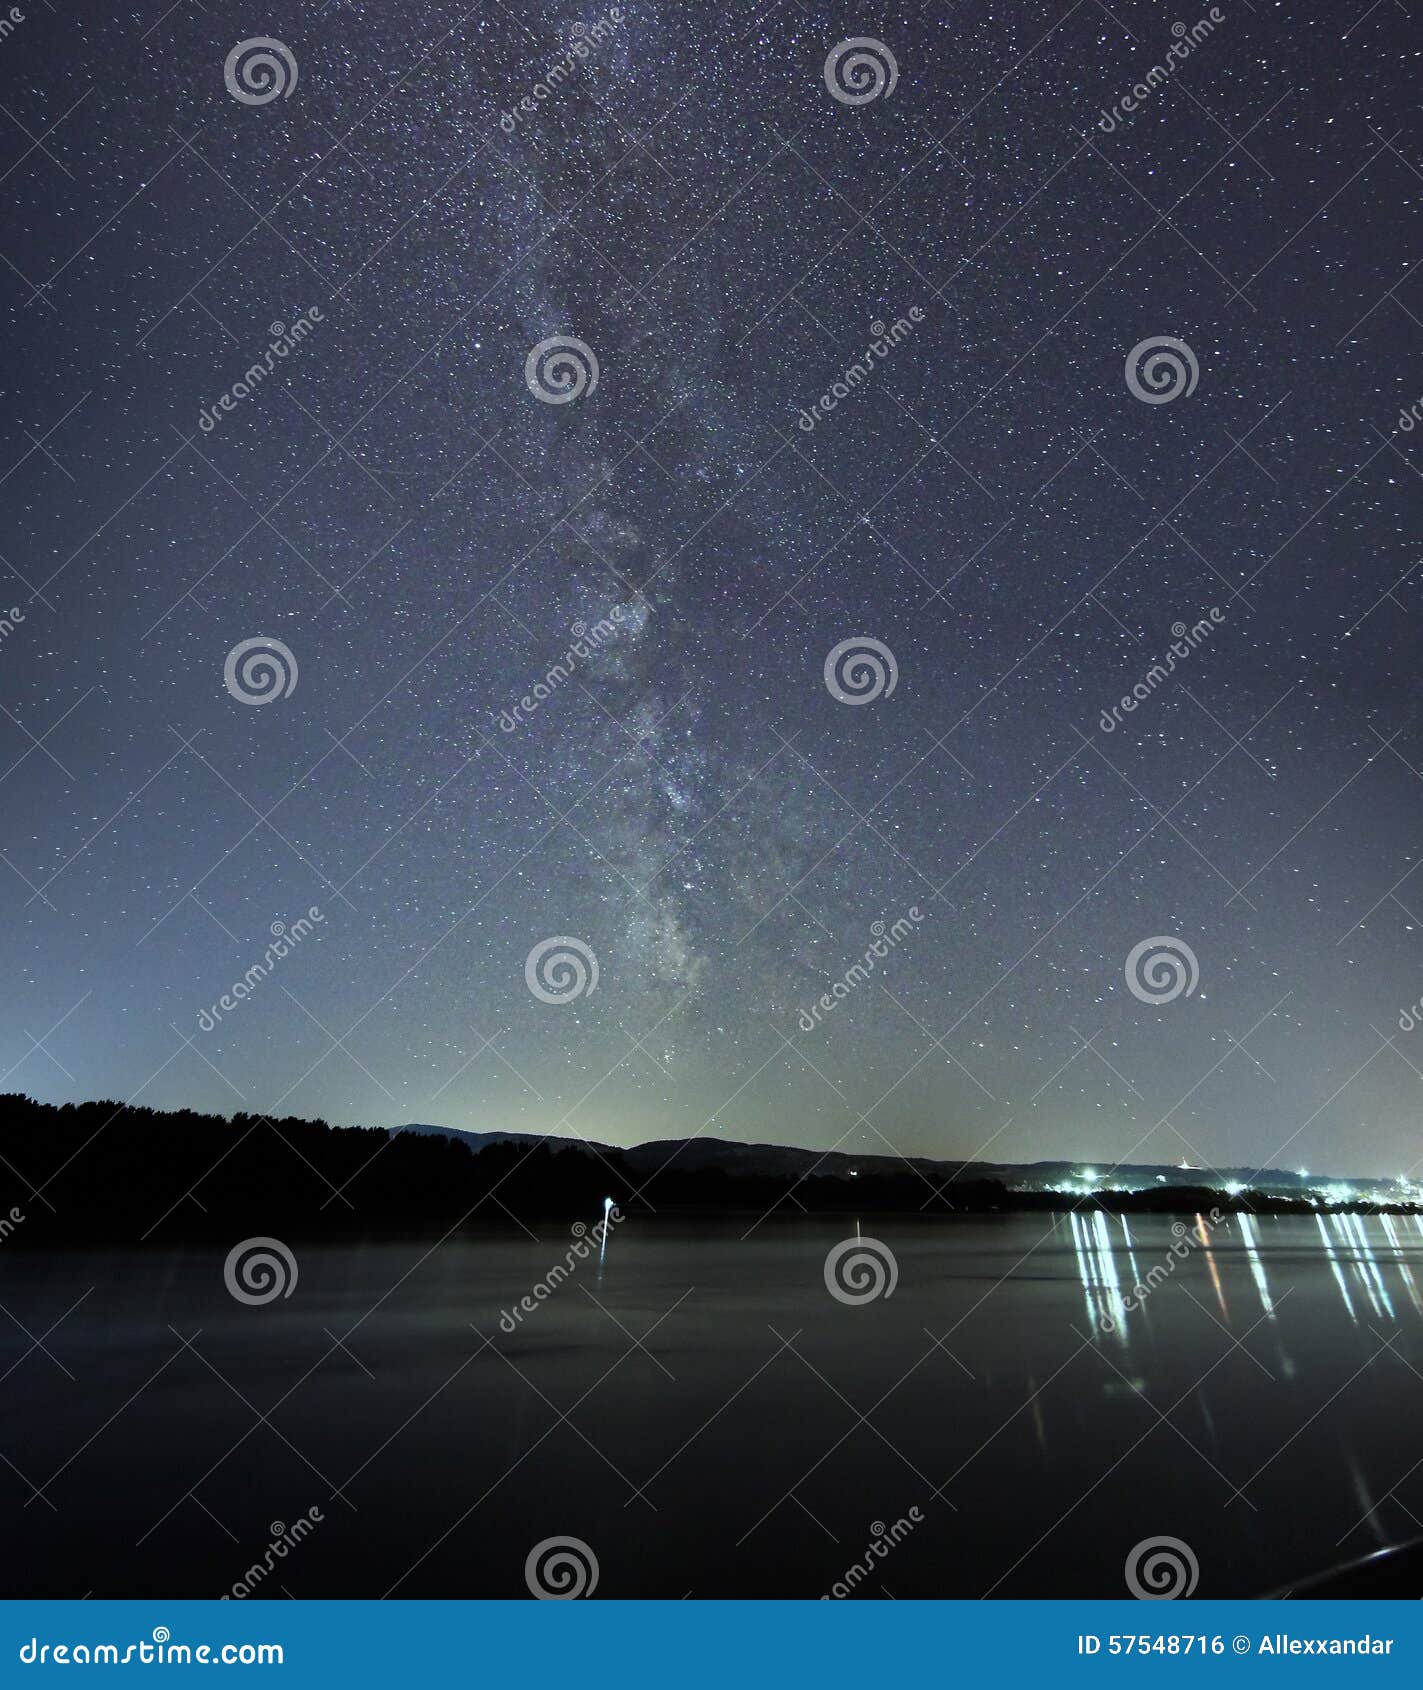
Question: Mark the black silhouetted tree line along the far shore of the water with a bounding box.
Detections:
[0,1093,1399,1246]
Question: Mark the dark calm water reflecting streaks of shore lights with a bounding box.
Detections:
[0,1217,1423,1599]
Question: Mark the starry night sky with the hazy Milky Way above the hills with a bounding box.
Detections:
[0,0,1423,1173]
